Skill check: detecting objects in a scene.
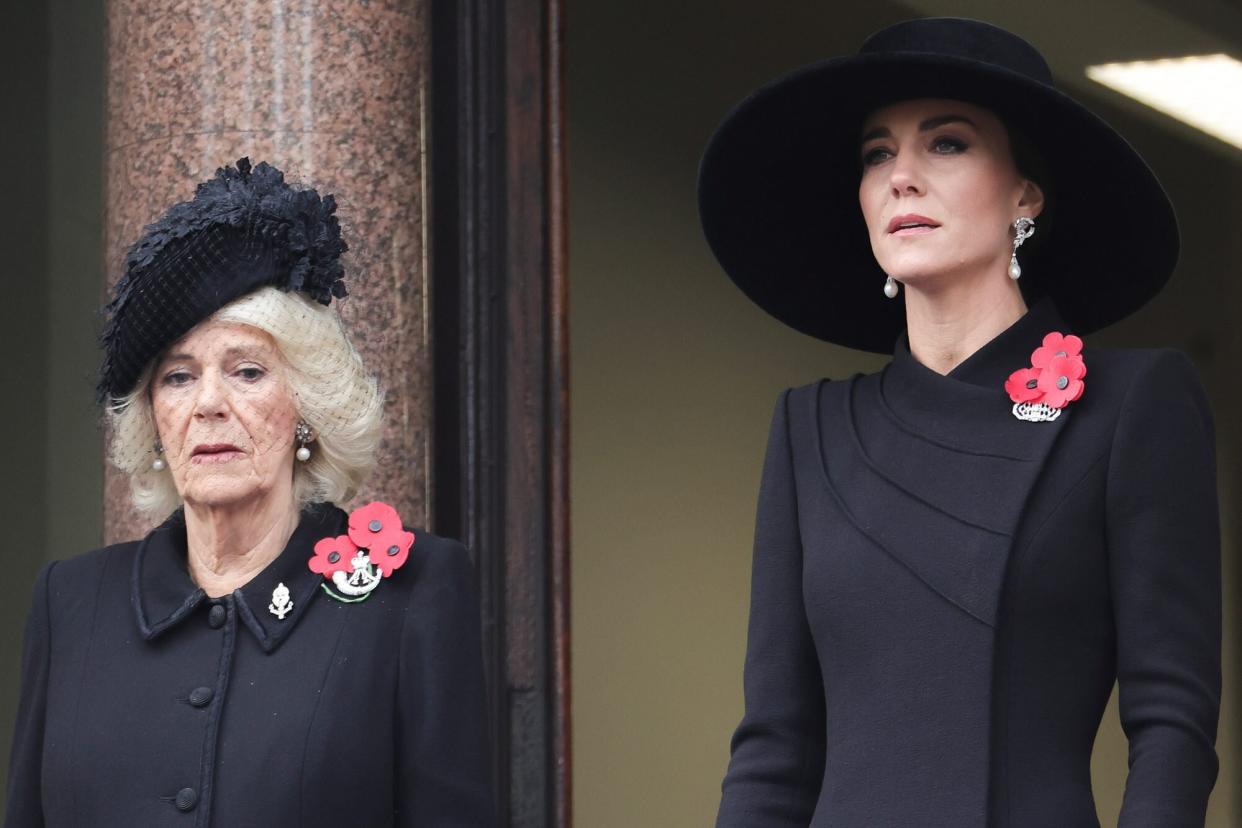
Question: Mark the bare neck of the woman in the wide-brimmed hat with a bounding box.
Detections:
[905,273,1026,374]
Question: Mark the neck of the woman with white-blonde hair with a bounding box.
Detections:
[185,493,298,597]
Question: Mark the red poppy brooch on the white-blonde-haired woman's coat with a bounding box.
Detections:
[307,500,414,603]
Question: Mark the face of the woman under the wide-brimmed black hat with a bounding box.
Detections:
[858,98,1043,289]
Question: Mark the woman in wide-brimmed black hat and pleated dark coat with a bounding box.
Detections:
[699,19,1221,828]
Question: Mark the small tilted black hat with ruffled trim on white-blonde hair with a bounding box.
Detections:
[98,158,347,402]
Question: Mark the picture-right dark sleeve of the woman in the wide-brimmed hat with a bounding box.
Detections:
[1107,351,1221,828]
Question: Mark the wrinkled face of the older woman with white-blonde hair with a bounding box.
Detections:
[152,319,297,506]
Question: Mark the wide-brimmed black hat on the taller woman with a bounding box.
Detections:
[698,17,1179,353]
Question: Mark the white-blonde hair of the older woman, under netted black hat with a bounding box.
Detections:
[106,288,384,519]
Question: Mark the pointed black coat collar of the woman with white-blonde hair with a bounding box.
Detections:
[130,504,348,652]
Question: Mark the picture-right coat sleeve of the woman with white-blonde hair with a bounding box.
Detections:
[395,539,496,828]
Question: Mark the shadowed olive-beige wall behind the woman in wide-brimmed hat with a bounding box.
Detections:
[568,0,1242,828]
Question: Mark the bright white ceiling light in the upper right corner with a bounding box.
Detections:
[1087,55,1242,149]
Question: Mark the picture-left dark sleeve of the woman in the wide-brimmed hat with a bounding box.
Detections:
[717,391,825,828]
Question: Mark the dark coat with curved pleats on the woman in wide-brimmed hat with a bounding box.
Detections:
[717,302,1221,828]
